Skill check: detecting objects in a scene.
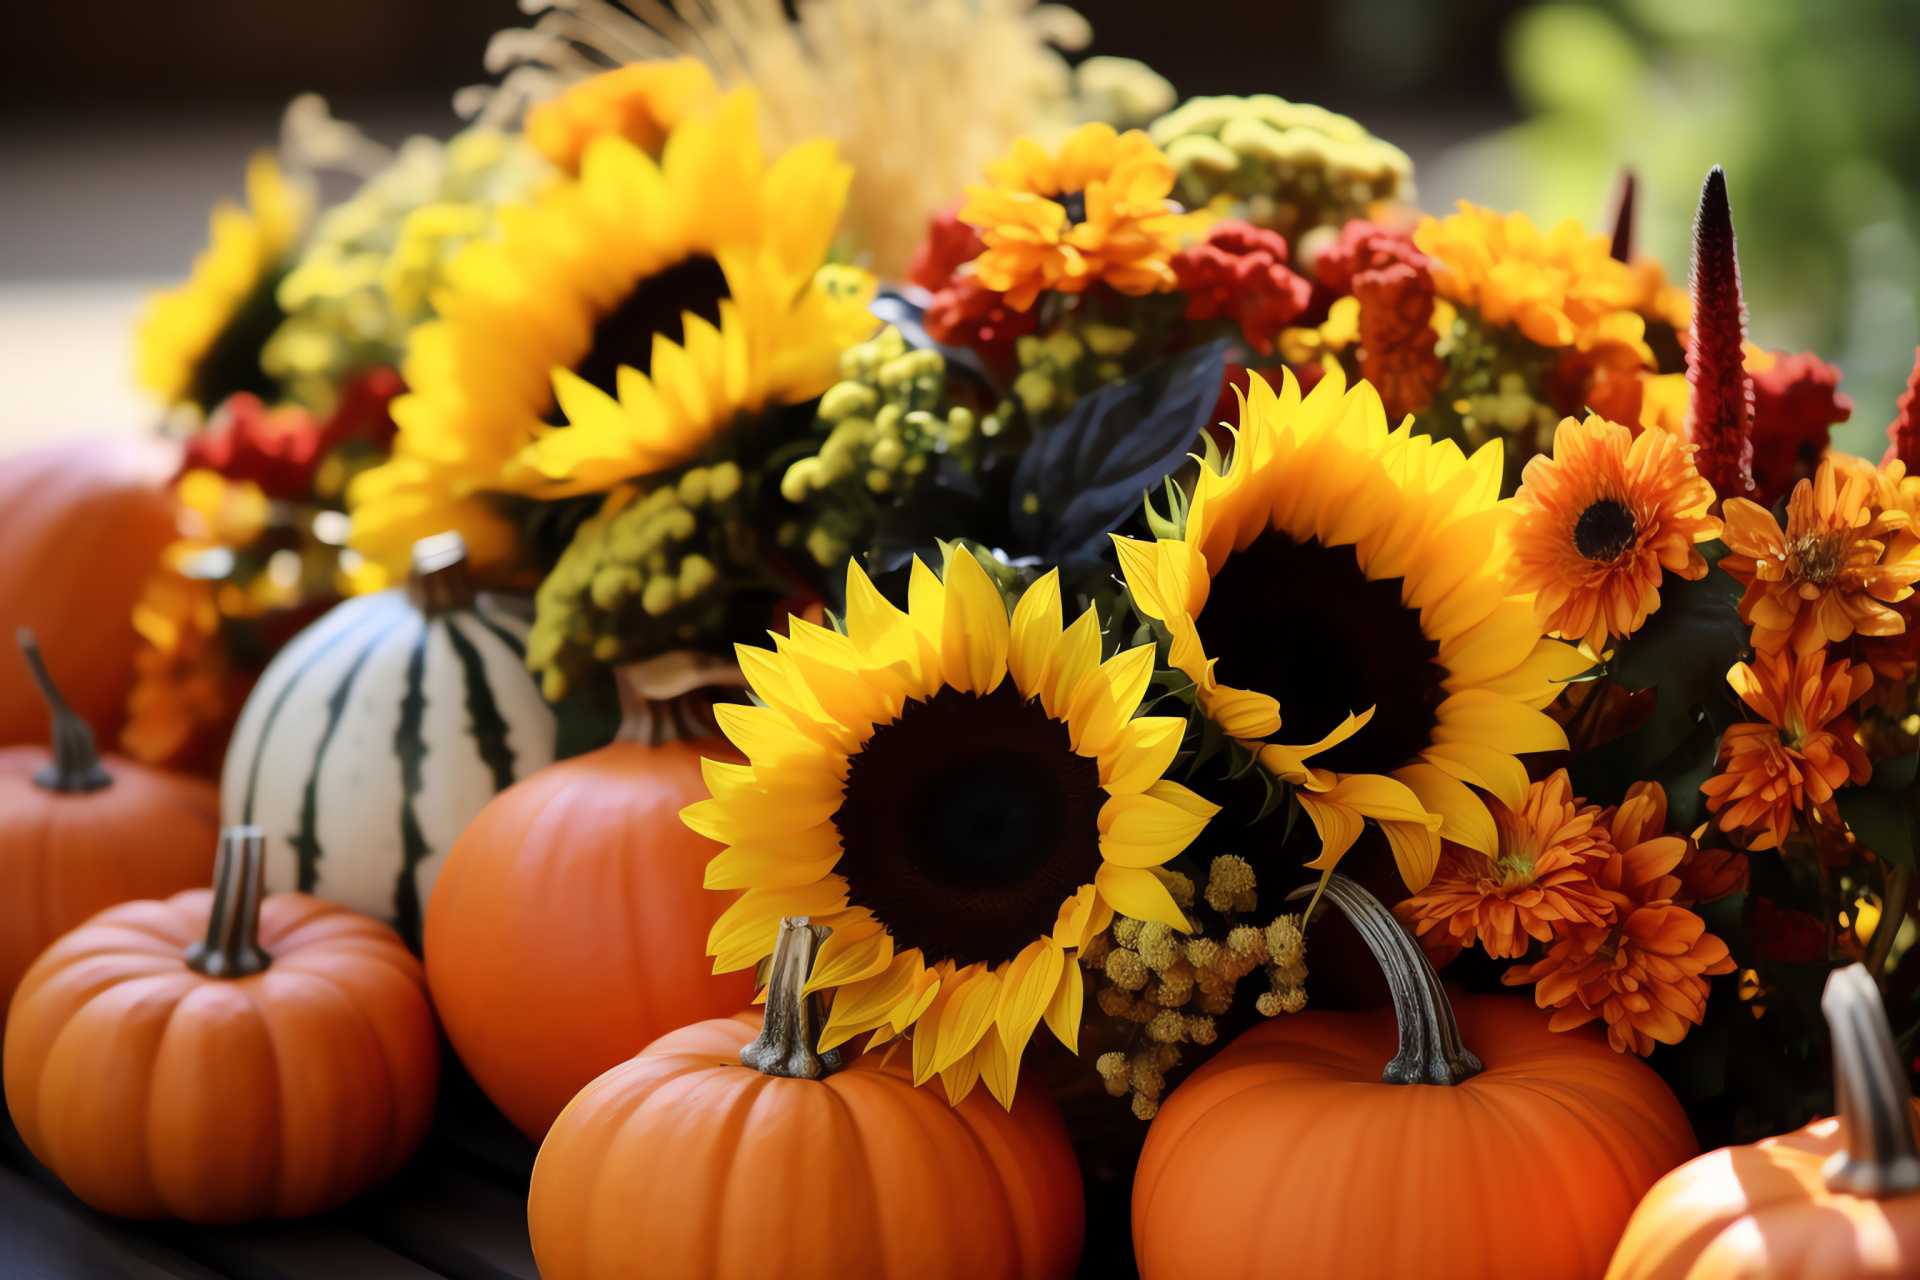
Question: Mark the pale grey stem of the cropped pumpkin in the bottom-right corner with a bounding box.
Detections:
[1820,965,1920,1199]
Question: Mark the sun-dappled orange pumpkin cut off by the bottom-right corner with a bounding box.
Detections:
[1607,965,1920,1280]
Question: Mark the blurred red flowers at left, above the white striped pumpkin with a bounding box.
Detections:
[180,368,405,501]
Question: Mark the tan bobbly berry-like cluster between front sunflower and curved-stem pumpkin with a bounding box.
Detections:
[1081,854,1308,1121]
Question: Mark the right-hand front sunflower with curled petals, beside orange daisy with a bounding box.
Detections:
[1114,370,1588,890]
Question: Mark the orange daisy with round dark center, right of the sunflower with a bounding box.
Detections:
[1507,416,1720,652]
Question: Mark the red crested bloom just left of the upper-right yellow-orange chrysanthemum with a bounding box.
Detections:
[1313,219,1446,420]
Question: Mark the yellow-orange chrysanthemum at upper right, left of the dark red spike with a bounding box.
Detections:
[1413,200,1659,368]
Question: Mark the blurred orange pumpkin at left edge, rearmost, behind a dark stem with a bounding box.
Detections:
[0,439,179,743]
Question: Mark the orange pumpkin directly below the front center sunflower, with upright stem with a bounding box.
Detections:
[526,917,1085,1280]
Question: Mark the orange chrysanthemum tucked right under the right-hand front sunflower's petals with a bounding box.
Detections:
[1394,770,1613,960]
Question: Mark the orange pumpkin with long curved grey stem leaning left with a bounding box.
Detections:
[1133,875,1697,1280]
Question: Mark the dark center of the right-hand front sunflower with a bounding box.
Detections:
[1198,530,1446,773]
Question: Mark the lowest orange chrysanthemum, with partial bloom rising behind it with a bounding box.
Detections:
[1501,783,1734,1055]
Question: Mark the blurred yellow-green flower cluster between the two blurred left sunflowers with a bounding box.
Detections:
[261,129,553,413]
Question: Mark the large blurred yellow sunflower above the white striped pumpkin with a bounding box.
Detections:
[351,90,877,579]
